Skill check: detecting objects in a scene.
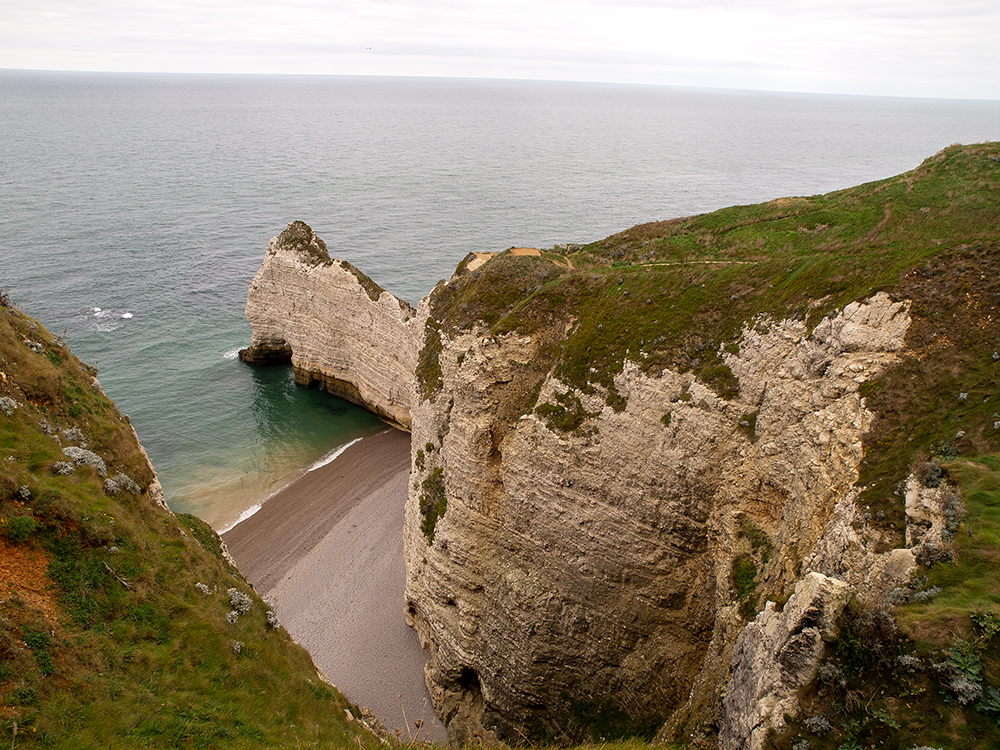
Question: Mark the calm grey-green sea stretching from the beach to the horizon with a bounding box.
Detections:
[0,71,1000,529]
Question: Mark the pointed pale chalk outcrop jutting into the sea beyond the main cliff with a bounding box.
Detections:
[240,221,421,429]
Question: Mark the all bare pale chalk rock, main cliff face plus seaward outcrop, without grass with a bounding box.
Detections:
[245,223,936,748]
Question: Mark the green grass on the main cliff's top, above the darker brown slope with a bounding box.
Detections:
[421,143,1000,424]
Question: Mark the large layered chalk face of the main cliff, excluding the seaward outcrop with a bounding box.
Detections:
[405,294,910,746]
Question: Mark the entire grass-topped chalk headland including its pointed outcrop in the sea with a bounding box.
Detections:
[241,144,1000,749]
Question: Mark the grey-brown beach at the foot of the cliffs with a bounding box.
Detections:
[223,429,447,744]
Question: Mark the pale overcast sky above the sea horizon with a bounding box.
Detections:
[0,0,1000,99]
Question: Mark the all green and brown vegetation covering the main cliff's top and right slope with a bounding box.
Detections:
[418,143,1000,750]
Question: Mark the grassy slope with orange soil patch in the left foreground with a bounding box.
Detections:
[0,298,379,748]
